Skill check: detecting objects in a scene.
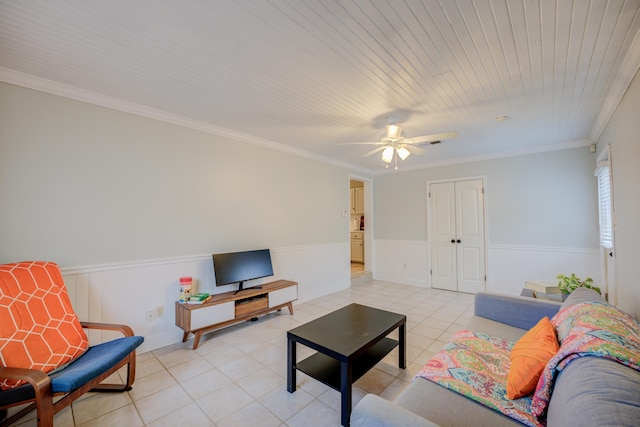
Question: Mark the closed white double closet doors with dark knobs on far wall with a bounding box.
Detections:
[429,179,486,293]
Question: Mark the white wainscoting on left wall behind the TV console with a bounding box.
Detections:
[62,242,350,353]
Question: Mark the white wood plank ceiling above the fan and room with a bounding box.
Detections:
[0,0,640,173]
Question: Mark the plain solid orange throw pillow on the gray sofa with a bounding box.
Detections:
[507,317,560,399]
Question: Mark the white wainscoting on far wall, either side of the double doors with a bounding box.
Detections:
[373,239,600,295]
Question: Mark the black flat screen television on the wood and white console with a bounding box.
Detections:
[213,249,273,292]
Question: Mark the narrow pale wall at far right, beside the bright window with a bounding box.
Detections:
[598,69,640,319]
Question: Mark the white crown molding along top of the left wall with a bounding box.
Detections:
[0,67,371,174]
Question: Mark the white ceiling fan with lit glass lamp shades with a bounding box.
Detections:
[342,116,458,169]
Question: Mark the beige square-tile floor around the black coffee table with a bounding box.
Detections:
[11,281,473,427]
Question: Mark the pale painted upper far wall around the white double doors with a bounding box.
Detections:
[374,147,598,249]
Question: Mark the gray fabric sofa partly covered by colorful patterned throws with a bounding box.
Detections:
[351,288,640,427]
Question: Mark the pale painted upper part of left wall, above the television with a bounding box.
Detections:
[0,84,350,267]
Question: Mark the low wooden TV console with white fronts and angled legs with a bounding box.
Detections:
[176,280,298,350]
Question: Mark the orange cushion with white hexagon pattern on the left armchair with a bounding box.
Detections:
[0,262,89,389]
